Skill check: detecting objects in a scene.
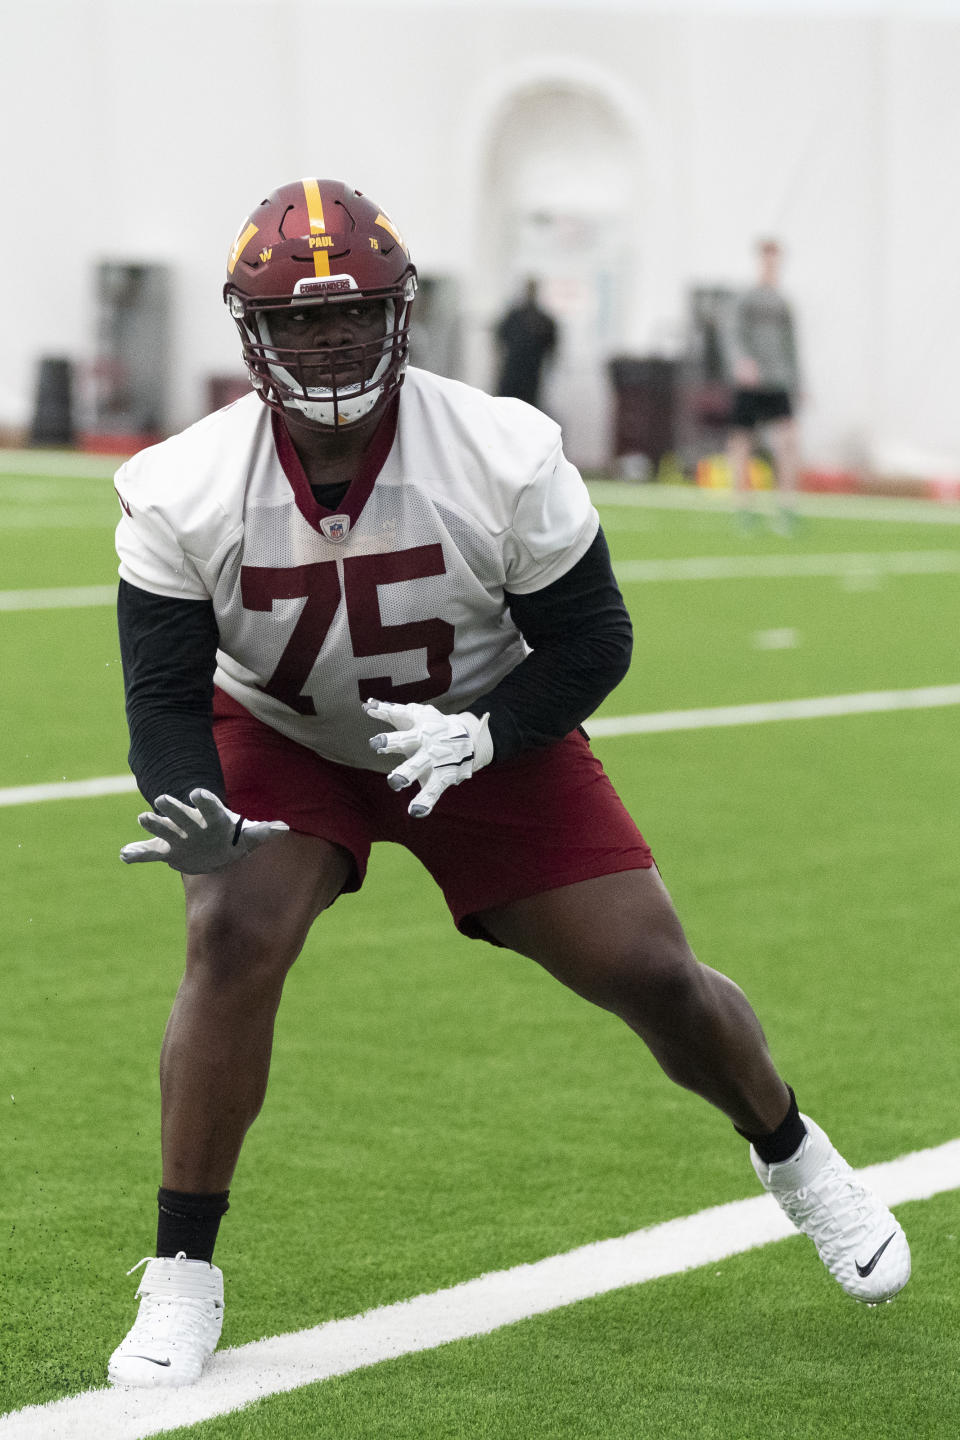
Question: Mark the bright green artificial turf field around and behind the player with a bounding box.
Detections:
[0,454,960,1440]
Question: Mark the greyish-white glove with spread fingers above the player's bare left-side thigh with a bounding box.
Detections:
[119,791,289,876]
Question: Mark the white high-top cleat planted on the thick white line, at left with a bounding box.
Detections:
[108,1250,223,1385]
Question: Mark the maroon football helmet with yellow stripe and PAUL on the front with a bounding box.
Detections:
[223,180,417,429]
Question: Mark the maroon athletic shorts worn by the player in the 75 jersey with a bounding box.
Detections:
[213,690,653,939]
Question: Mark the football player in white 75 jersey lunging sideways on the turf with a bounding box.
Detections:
[109,179,910,1385]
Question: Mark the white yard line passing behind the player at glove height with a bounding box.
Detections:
[0,685,960,808]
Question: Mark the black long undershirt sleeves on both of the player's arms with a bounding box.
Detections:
[118,531,632,804]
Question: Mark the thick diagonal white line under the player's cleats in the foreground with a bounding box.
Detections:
[0,1140,960,1440]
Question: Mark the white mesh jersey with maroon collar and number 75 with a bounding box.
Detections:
[117,369,599,770]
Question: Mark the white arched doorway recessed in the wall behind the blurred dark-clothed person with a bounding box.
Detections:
[481,81,639,468]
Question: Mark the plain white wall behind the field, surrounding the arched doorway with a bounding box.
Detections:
[0,0,960,474]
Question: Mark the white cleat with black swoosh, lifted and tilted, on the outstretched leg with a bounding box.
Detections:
[750,1115,910,1305]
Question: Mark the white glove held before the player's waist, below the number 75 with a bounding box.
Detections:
[363,700,494,819]
